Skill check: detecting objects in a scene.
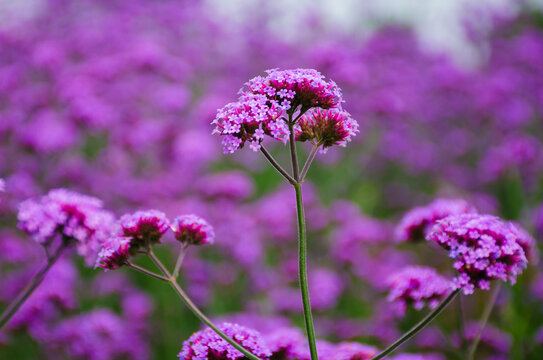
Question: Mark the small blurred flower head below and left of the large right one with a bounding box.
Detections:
[387,266,452,315]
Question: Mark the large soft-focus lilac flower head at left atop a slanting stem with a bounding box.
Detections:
[18,189,114,260]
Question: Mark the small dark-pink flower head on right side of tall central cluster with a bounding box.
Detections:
[296,109,358,151]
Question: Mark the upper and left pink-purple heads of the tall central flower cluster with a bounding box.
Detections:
[212,69,344,154]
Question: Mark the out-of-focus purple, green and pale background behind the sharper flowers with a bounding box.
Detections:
[0,0,543,360]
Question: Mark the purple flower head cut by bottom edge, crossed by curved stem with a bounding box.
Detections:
[178,323,271,360]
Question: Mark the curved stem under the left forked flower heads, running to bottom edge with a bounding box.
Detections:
[147,249,262,360]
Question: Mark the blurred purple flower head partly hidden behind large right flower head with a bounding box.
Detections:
[395,199,477,242]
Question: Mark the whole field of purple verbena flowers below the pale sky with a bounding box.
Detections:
[0,0,543,360]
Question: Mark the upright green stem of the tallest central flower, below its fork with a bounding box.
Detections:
[294,184,319,360]
